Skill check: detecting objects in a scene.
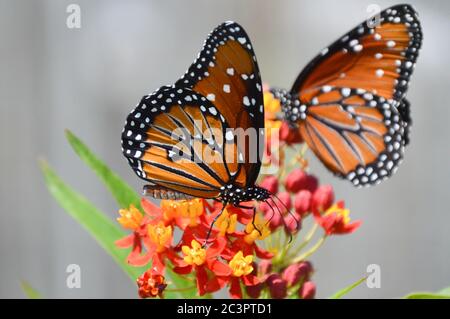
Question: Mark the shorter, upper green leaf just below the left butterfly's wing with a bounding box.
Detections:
[65,130,142,211]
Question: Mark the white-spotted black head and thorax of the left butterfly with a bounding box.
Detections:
[220,184,271,205]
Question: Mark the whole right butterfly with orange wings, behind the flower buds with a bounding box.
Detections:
[271,5,422,186]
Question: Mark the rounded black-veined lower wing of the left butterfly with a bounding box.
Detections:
[122,87,255,198]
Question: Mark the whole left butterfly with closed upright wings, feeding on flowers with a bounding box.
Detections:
[122,22,292,234]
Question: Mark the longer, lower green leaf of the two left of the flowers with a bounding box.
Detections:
[40,161,145,282]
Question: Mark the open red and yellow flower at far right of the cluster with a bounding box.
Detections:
[315,201,361,236]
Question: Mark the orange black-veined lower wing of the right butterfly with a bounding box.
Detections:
[299,87,405,186]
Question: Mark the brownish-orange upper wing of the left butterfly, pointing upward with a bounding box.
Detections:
[175,22,264,186]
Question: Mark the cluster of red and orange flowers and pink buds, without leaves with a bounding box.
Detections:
[116,85,361,299]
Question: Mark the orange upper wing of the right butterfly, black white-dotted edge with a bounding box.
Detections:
[292,5,422,101]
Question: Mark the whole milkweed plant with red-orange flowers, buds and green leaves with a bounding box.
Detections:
[36,91,450,299]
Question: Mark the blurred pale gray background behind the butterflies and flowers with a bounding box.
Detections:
[0,0,450,298]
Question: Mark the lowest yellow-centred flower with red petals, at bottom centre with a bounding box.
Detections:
[229,250,259,299]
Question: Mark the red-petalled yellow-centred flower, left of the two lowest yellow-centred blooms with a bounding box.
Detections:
[173,237,231,296]
